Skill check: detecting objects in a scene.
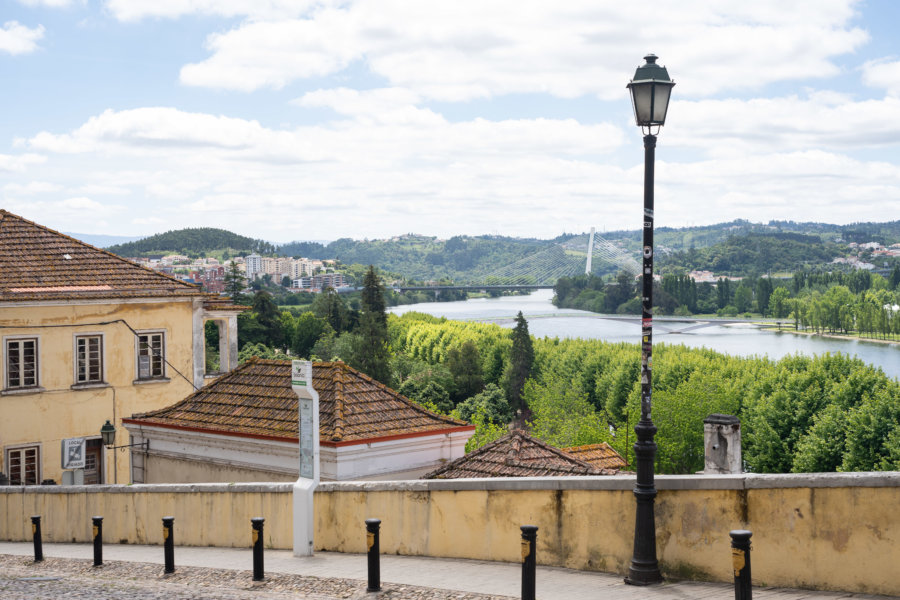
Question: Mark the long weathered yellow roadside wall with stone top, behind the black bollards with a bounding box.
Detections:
[0,472,900,595]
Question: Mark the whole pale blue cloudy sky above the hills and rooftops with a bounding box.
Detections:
[0,0,900,243]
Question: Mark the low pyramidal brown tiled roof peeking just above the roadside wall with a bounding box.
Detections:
[422,430,615,479]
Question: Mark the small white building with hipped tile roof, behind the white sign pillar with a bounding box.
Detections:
[122,358,475,483]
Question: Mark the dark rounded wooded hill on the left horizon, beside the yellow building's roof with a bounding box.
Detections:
[107,227,275,256]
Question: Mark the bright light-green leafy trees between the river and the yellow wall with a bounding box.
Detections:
[389,308,900,473]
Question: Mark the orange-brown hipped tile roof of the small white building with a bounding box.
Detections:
[125,358,471,444]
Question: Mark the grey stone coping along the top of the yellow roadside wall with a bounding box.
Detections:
[0,471,900,494]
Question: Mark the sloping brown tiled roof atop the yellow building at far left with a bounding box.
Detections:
[0,209,207,302]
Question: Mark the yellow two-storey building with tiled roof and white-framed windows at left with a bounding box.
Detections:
[0,210,241,485]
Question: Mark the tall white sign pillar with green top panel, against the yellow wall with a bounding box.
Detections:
[291,360,319,556]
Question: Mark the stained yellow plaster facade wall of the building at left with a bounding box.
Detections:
[0,299,193,483]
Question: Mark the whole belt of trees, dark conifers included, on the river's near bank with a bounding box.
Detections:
[229,268,900,473]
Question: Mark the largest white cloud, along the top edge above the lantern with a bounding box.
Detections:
[172,0,868,101]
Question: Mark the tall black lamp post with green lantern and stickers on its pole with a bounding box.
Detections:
[625,54,675,585]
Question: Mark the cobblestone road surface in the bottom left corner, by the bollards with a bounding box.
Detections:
[0,555,512,600]
